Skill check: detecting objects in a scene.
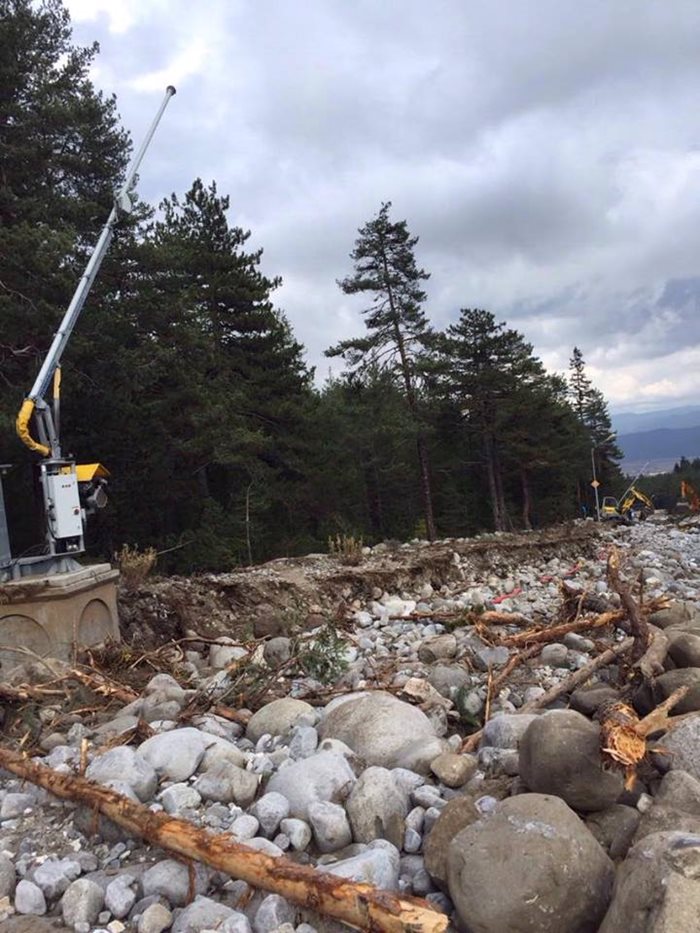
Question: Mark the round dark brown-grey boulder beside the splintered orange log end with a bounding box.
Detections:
[520,710,624,812]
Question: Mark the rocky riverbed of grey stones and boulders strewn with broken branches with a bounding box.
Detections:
[0,517,700,933]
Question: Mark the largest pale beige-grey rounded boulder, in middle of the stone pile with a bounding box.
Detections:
[320,691,446,774]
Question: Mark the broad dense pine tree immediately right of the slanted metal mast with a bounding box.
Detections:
[66,180,310,569]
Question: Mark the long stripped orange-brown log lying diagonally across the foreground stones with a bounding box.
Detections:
[0,748,448,933]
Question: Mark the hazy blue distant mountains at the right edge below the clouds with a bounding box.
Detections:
[612,405,700,473]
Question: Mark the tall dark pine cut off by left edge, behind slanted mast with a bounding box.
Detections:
[0,0,129,553]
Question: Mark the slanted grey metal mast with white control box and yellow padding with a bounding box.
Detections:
[0,87,175,582]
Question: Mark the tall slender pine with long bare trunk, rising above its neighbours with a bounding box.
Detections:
[326,202,436,541]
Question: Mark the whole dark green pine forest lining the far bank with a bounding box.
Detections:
[0,0,624,572]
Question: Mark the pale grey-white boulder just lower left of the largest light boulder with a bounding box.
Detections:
[267,751,356,820]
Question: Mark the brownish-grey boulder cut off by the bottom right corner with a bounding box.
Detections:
[599,832,700,933]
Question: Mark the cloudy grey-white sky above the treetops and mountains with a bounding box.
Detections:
[66,0,700,411]
